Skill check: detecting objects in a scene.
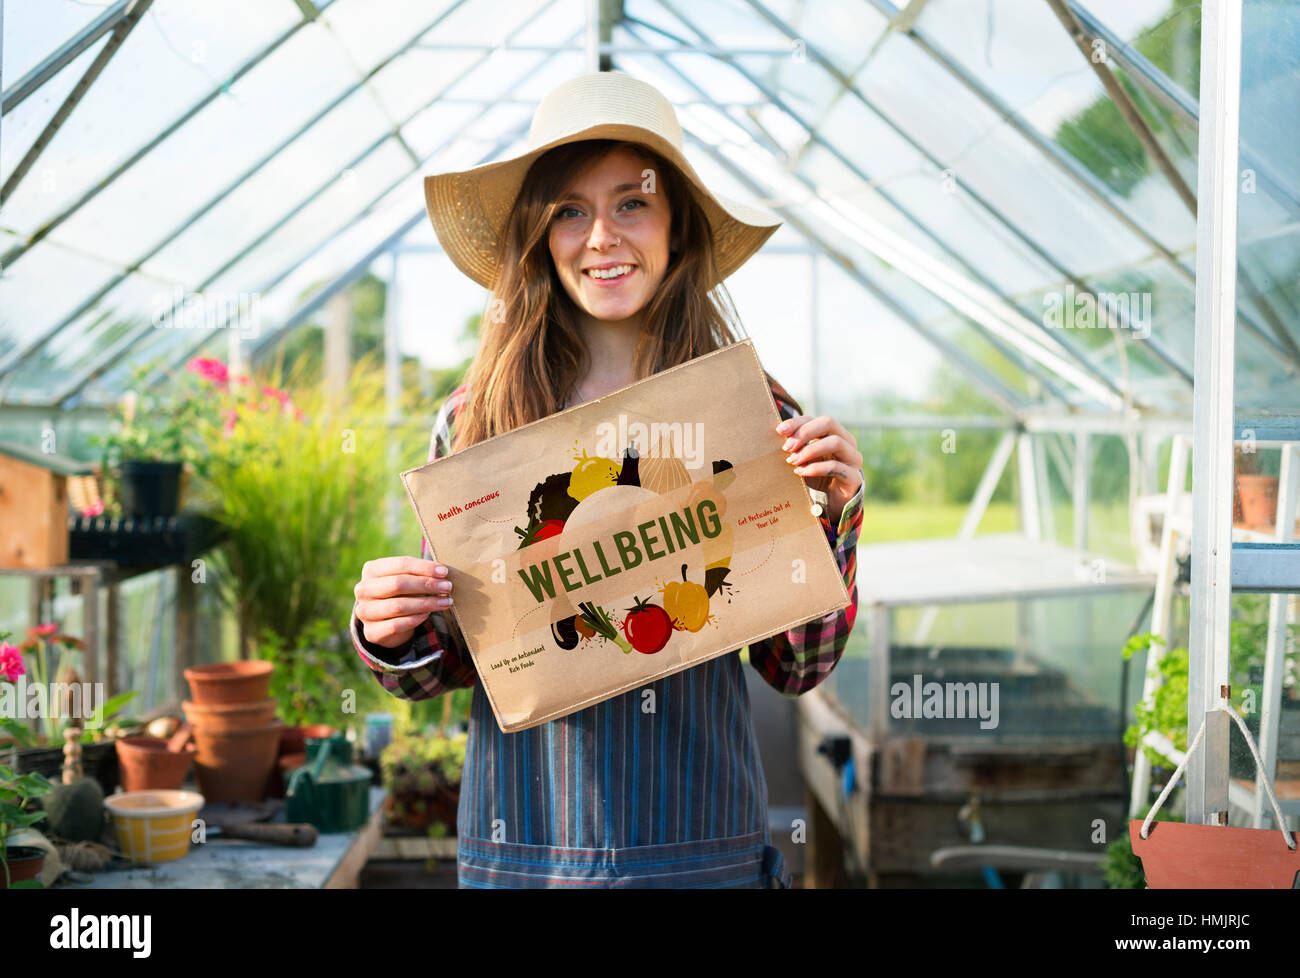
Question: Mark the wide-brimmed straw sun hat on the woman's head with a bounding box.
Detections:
[424,72,781,289]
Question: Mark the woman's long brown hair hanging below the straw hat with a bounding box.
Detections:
[455,139,785,451]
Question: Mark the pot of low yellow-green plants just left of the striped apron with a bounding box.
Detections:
[380,734,468,835]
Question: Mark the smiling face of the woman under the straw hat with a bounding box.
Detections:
[547,148,672,329]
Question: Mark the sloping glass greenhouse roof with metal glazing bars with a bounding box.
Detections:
[0,0,1300,415]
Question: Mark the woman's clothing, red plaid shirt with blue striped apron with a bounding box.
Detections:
[351,371,863,887]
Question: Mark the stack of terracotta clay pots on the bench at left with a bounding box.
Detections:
[185,661,283,802]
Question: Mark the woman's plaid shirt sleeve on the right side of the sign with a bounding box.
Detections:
[749,397,866,696]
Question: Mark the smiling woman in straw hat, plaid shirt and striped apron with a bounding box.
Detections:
[352,73,863,887]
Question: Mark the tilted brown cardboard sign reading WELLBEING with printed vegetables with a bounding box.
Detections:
[402,339,849,732]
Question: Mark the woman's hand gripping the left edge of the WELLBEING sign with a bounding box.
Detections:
[352,557,451,649]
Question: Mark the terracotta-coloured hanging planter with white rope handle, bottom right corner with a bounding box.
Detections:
[1128,700,1300,890]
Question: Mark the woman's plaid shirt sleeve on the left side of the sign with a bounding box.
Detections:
[351,385,477,700]
